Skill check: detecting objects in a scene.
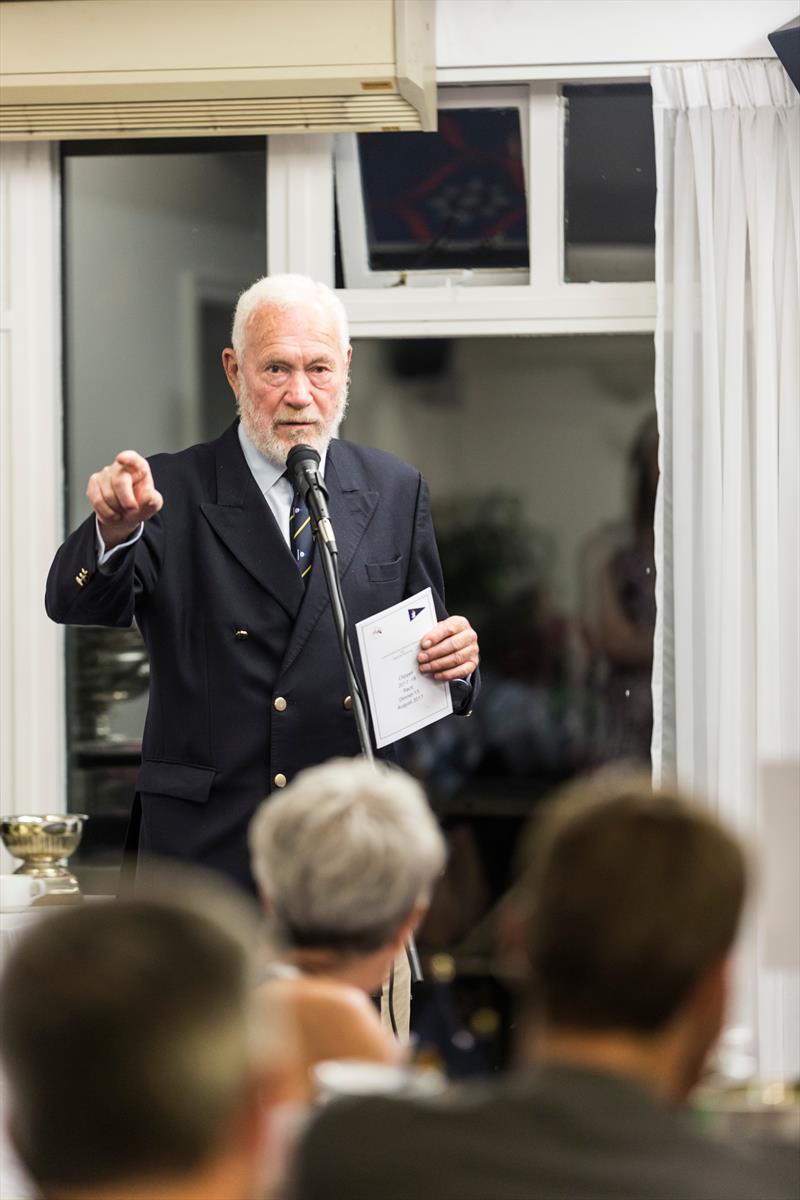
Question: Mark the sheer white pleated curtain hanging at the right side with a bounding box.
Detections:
[652,60,800,1078]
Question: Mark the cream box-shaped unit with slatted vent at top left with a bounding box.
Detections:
[0,0,437,142]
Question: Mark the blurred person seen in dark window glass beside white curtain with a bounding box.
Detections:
[579,414,658,763]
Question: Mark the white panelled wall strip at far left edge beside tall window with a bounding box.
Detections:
[0,143,66,854]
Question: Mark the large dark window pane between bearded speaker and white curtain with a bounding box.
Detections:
[343,335,657,1032]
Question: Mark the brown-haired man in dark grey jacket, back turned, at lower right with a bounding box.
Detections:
[291,768,800,1200]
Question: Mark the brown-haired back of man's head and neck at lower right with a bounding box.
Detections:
[517,768,746,1098]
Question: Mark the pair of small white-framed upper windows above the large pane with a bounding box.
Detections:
[319,80,655,337]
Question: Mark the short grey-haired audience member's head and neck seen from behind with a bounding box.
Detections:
[249,758,445,1094]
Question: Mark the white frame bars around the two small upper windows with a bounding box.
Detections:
[267,75,656,337]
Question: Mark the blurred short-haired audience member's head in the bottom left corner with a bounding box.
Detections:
[0,878,293,1200]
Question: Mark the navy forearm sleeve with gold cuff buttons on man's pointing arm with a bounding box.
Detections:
[44,514,163,628]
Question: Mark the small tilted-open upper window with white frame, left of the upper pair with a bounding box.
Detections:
[336,90,529,287]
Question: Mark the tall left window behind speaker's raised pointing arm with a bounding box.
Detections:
[62,138,266,892]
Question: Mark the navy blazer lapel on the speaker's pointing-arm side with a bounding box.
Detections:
[200,424,304,617]
